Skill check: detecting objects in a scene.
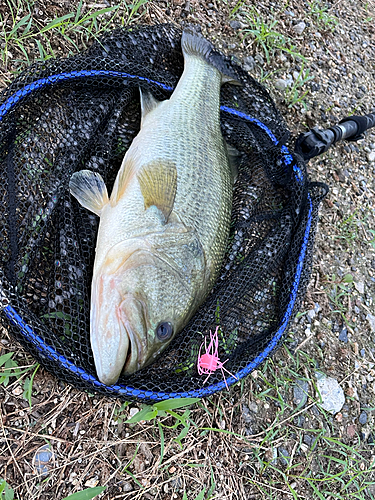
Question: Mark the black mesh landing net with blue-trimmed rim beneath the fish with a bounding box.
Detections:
[0,25,326,400]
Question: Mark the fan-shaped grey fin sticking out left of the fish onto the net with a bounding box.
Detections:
[69,170,109,216]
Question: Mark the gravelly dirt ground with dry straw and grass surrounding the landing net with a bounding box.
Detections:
[0,0,375,500]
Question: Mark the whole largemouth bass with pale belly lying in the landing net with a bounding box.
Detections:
[70,30,237,385]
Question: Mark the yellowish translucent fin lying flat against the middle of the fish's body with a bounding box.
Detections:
[137,160,177,221]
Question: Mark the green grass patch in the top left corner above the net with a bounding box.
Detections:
[0,0,148,82]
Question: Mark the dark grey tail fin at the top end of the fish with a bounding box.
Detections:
[181,28,241,85]
